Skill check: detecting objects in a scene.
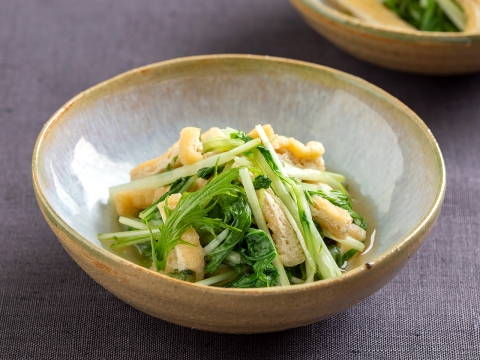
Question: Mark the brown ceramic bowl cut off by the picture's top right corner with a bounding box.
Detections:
[290,0,480,75]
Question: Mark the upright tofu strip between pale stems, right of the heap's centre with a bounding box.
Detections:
[262,189,305,267]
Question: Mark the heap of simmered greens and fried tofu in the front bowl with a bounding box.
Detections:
[98,125,367,288]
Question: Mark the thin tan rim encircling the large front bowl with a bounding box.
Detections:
[32,54,446,295]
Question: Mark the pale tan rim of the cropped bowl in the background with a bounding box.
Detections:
[290,0,480,41]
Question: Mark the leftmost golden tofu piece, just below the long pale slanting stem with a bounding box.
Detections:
[115,186,168,217]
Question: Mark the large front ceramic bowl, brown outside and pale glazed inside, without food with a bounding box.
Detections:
[33,55,445,333]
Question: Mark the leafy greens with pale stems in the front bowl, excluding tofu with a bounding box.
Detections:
[103,124,370,288]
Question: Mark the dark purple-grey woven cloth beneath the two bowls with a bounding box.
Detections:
[0,0,480,359]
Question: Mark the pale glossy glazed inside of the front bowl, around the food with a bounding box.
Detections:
[34,55,443,266]
